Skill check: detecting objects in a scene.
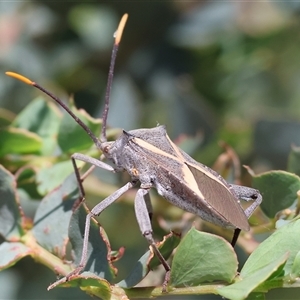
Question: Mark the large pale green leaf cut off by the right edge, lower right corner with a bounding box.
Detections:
[241,218,300,277]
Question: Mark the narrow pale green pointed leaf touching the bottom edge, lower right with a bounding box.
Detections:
[218,253,288,300]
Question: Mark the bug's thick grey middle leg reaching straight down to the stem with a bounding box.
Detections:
[134,188,171,292]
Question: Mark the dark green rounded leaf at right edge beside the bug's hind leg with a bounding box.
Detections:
[253,171,300,218]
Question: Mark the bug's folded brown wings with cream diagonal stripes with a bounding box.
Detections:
[131,138,249,230]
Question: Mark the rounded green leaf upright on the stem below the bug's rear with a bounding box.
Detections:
[170,228,238,286]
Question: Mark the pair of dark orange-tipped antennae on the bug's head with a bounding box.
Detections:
[5,14,128,148]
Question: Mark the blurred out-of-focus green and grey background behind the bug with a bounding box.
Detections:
[0,1,300,299]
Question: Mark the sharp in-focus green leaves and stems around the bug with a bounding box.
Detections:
[0,98,300,300]
